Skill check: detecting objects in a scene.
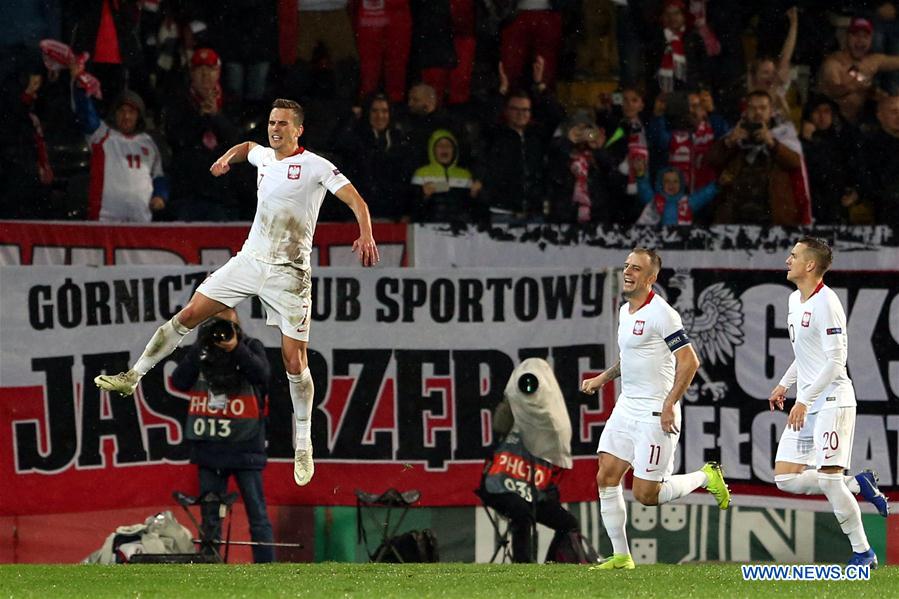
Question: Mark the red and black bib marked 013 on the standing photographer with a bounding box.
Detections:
[187,378,262,443]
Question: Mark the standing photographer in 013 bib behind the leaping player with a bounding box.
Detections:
[172,309,275,563]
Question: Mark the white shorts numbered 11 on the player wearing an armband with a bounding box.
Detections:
[596,410,681,482]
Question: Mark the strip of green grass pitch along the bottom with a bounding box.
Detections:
[0,563,899,599]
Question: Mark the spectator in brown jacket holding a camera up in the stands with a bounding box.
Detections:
[706,91,803,226]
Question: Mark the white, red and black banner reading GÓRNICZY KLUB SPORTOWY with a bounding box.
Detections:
[0,266,611,515]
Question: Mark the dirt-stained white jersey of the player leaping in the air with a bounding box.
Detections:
[241,146,350,270]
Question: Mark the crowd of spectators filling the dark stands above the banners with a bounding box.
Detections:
[0,0,899,226]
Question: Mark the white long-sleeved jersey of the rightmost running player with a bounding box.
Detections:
[787,283,855,414]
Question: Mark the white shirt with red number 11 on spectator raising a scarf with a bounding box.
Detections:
[88,122,163,222]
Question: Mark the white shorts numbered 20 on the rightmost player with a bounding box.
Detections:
[774,407,855,469]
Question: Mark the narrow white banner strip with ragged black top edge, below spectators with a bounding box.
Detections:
[414,225,899,271]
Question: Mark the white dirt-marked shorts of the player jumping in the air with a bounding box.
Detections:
[197,252,312,341]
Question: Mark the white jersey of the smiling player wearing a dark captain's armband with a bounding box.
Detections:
[615,292,690,422]
